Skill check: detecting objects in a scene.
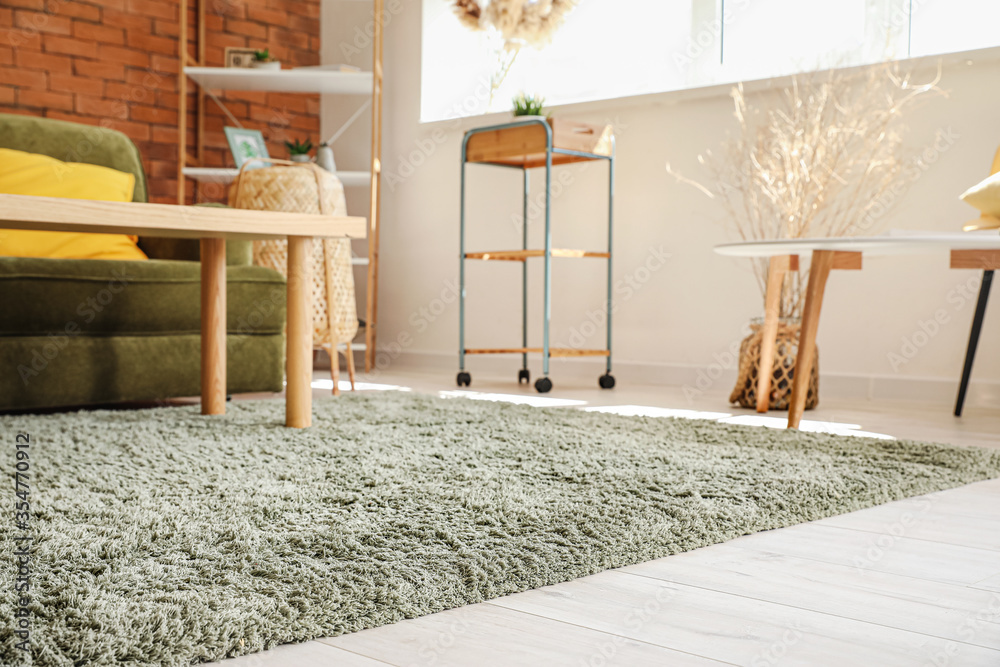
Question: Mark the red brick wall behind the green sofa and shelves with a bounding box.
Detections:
[0,0,320,203]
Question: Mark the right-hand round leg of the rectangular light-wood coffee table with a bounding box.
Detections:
[285,236,312,428]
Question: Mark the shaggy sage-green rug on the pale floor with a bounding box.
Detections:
[0,393,1000,666]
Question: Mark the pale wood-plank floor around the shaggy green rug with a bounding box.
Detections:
[216,373,1000,667]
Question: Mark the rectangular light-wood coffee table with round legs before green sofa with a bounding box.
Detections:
[0,194,367,428]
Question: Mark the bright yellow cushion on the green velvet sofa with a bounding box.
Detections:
[0,148,146,260]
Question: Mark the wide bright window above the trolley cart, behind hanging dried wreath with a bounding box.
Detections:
[421,0,1000,122]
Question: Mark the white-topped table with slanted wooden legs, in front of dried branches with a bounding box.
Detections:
[715,232,1000,428]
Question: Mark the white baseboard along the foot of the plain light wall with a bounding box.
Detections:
[380,351,1000,408]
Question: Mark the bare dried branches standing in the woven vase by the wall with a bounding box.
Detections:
[667,63,941,318]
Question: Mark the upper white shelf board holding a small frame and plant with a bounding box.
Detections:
[184,67,372,95]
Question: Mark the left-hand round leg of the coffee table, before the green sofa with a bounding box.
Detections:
[201,239,226,415]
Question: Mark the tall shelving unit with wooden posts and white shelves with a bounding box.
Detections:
[177,0,384,371]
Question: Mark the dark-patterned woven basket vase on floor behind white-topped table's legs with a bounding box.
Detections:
[729,320,819,410]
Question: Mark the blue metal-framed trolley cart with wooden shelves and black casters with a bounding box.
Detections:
[457,117,615,394]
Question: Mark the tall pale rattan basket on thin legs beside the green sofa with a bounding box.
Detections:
[229,160,358,394]
